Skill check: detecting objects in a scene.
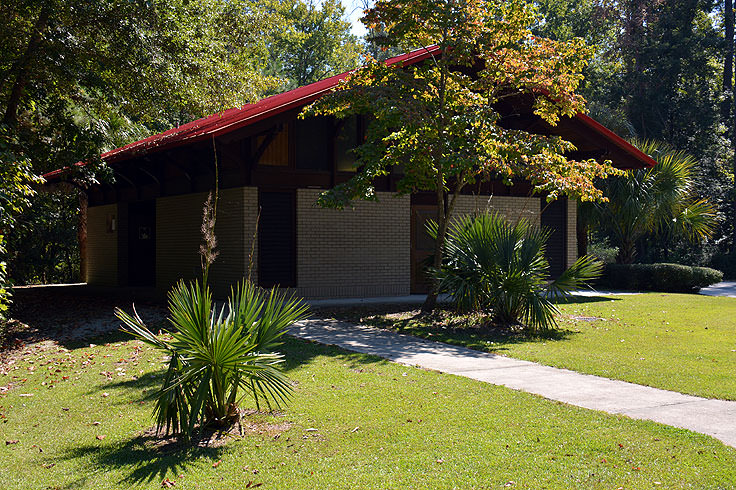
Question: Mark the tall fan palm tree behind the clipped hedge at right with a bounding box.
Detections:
[595,141,716,264]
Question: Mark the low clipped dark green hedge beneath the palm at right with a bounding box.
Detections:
[596,264,723,293]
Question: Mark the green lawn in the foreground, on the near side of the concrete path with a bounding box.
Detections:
[0,332,736,489]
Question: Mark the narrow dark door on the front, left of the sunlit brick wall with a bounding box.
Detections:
[258,191,296,287]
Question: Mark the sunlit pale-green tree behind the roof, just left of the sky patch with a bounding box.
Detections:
[265,0,361,89]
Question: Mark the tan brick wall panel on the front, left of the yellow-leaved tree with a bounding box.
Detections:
[296,189,411,298]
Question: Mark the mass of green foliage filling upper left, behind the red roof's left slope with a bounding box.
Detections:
[0,0,358,284]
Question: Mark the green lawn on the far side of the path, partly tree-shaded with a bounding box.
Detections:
[328,293,736,400]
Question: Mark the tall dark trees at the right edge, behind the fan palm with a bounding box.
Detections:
[535,0,736,274]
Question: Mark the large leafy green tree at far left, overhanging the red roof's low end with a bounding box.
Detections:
[0,0,278,286]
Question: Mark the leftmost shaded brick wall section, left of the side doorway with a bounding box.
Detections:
[86,204,118,286]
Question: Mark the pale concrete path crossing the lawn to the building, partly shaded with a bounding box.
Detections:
[291,319,736,447]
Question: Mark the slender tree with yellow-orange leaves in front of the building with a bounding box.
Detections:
[306,0,615,311]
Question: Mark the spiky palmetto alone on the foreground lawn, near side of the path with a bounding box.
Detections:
[115,280,307,439]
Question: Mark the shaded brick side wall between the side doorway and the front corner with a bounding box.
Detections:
[156,187,258,297]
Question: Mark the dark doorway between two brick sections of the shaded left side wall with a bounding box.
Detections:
[128,201,156,287]
